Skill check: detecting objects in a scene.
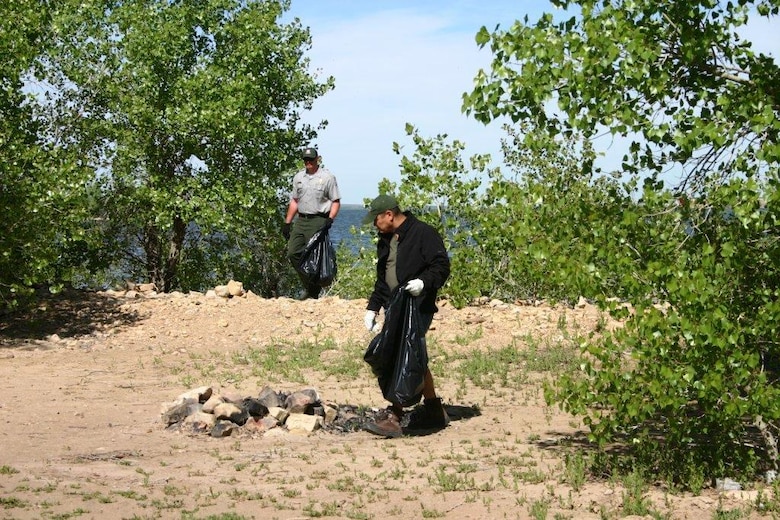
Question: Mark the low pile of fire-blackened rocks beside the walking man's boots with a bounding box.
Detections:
[161,386,376,437]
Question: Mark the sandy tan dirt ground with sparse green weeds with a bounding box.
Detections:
[0,293,772,519]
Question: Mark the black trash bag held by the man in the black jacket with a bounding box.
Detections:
[363,286,428,406]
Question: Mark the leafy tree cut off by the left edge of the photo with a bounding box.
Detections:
[0,0,93,310]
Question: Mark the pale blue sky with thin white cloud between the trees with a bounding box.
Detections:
[287,0,780,204]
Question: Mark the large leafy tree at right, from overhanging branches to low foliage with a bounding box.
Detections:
[464,0,780,484]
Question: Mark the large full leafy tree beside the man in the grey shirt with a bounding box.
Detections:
[39,0,333,294]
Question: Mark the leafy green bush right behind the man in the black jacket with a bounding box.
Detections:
[380,125,631,305]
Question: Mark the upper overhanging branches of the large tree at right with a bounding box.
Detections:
[464,0,780,190]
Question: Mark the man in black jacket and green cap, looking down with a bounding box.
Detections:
[363,195,450,437]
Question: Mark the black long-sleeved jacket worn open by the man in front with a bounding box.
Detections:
[367,211,450,314]
